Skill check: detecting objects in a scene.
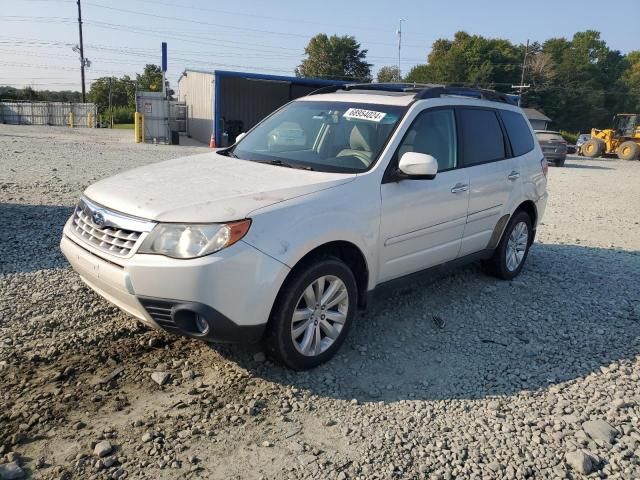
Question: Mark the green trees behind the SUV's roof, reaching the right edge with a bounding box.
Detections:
[295,30,640,132]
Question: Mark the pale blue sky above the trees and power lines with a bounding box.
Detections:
[0,0,640,91]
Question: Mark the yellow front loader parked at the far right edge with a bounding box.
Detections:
[581,113,640,160]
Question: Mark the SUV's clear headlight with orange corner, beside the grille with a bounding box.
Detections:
[138,219,251,258]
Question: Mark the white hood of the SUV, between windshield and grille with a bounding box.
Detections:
[84,152,355,223]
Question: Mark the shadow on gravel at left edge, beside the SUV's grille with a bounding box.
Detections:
[0,203,73,274]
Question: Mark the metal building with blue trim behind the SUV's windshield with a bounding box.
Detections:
[178,69,350,146]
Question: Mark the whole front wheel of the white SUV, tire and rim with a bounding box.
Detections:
[265,257,358,370]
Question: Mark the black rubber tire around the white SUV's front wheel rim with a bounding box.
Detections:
[264,257,358,370]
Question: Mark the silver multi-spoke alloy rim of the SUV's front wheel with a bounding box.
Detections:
[291,275,349,357]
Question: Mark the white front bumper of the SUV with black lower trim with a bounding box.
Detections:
[60,222,289,342]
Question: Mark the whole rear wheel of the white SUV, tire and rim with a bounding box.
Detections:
[483,212,533,280]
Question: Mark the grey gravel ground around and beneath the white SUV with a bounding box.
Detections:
[0,125,640,479]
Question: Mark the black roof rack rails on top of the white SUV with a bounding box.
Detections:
[309,83,516,105]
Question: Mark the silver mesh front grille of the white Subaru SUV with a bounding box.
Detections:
[72,200,142,257]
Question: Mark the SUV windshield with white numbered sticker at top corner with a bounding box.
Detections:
[229,101,406,173]
